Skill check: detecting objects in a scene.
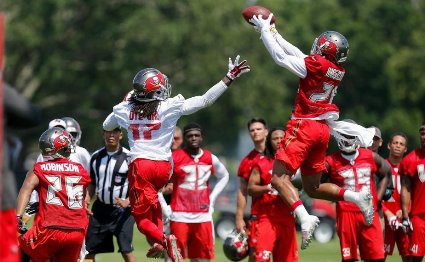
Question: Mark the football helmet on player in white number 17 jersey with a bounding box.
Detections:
[132,68,171,102]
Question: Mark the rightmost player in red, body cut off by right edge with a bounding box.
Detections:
[398,122,425,262]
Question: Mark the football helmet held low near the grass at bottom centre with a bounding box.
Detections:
[223,229,249,261]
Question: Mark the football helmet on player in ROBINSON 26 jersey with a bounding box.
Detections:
[38,127,72,160]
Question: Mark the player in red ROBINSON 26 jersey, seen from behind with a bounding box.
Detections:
[16,127,90,262]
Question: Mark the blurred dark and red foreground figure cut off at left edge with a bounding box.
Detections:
[0,84,41,262]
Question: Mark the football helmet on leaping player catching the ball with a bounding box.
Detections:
[310,31,349,63]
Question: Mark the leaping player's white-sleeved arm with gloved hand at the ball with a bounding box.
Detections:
[252,14,307,78]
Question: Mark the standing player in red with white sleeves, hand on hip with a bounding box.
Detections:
[165,123,229,262]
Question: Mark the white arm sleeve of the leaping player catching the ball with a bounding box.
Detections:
[261,30,307,78]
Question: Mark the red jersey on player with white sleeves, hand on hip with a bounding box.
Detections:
[171,149,214,213]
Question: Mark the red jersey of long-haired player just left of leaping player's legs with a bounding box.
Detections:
[251,156,294,224]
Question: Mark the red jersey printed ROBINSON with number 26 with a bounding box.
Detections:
[34,159,90,230]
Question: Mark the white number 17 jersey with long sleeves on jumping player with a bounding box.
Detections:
[103,81,227,161]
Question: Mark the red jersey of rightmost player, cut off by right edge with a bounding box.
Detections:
[399,148,425,215]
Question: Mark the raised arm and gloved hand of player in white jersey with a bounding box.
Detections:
[182,55,250,115]
